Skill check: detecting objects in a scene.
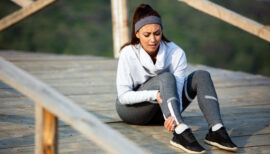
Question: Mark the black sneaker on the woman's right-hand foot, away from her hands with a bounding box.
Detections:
[204,127,237,151]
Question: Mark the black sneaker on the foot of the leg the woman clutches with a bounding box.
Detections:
[170,128,205,153]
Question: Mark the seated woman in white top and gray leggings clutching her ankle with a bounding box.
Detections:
[116,4,237,153]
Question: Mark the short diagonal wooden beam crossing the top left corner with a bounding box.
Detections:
[0,0,56,31]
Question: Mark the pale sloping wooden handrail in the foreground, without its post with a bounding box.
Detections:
[0,58,145,154]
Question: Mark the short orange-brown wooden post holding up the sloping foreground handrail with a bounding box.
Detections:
[35,103,58,154]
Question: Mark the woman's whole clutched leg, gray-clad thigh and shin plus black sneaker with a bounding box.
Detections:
[116,73,205,153]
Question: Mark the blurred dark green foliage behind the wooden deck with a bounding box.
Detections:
[0,0,270,76]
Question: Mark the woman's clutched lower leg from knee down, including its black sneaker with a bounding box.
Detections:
[141,73,205,153]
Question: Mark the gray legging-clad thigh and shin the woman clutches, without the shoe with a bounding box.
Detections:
[116,72,182,125]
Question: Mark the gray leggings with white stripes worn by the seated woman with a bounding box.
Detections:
[116,70,222,127]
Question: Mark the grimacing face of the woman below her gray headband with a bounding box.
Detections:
[136,24,162,55]
